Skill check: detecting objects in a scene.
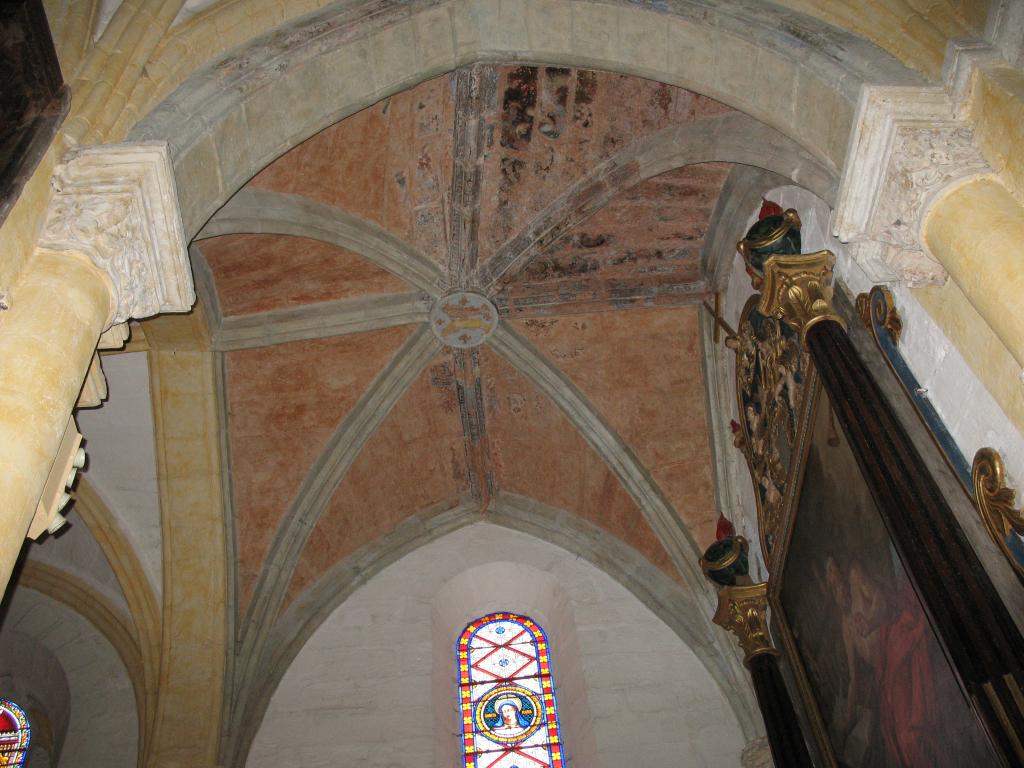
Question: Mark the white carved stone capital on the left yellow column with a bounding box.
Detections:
[39,142,196,328]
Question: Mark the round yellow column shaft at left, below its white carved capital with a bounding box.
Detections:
[0,250,112,589]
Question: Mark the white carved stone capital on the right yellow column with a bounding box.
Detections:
[833,86,989,286]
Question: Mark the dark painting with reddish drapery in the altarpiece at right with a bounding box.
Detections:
[780,394,995,768]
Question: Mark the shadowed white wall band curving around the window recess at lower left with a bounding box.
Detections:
[0,588,138,768]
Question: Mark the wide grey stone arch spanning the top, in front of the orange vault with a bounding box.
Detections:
[130,0,922,239]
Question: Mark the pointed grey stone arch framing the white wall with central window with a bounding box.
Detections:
[221,493,763,768]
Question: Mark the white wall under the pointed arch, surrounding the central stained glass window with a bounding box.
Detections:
[247,523,743,768]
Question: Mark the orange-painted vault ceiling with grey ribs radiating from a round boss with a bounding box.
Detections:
[193,65,735,615]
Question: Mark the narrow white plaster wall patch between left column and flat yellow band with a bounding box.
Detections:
[72,352,163,599]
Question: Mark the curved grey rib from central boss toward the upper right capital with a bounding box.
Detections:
[475,113,836,293]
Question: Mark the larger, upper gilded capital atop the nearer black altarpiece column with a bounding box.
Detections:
[758,251,844,339]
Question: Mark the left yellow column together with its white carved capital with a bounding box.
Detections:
[0,142,196,602]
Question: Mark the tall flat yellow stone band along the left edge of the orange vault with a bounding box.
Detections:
[144,309,224,768]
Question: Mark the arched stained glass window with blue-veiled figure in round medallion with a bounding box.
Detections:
[458,613,564,768]
